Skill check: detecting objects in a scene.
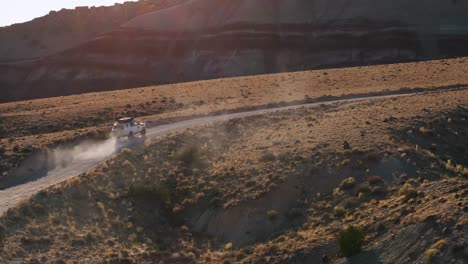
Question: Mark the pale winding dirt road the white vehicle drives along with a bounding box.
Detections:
[0,92,450,215]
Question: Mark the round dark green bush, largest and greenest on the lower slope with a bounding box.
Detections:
[338,226,366,257]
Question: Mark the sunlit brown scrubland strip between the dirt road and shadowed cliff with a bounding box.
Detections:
[0,58,468,186]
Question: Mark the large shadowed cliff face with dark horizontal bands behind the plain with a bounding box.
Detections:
[0,0,468,101]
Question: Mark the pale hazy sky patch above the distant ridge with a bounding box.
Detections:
[0,0,136,26]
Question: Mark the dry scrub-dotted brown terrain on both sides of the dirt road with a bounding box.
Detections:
[0,55,468,263]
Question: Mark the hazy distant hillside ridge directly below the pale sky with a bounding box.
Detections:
[0,0,185,63]
